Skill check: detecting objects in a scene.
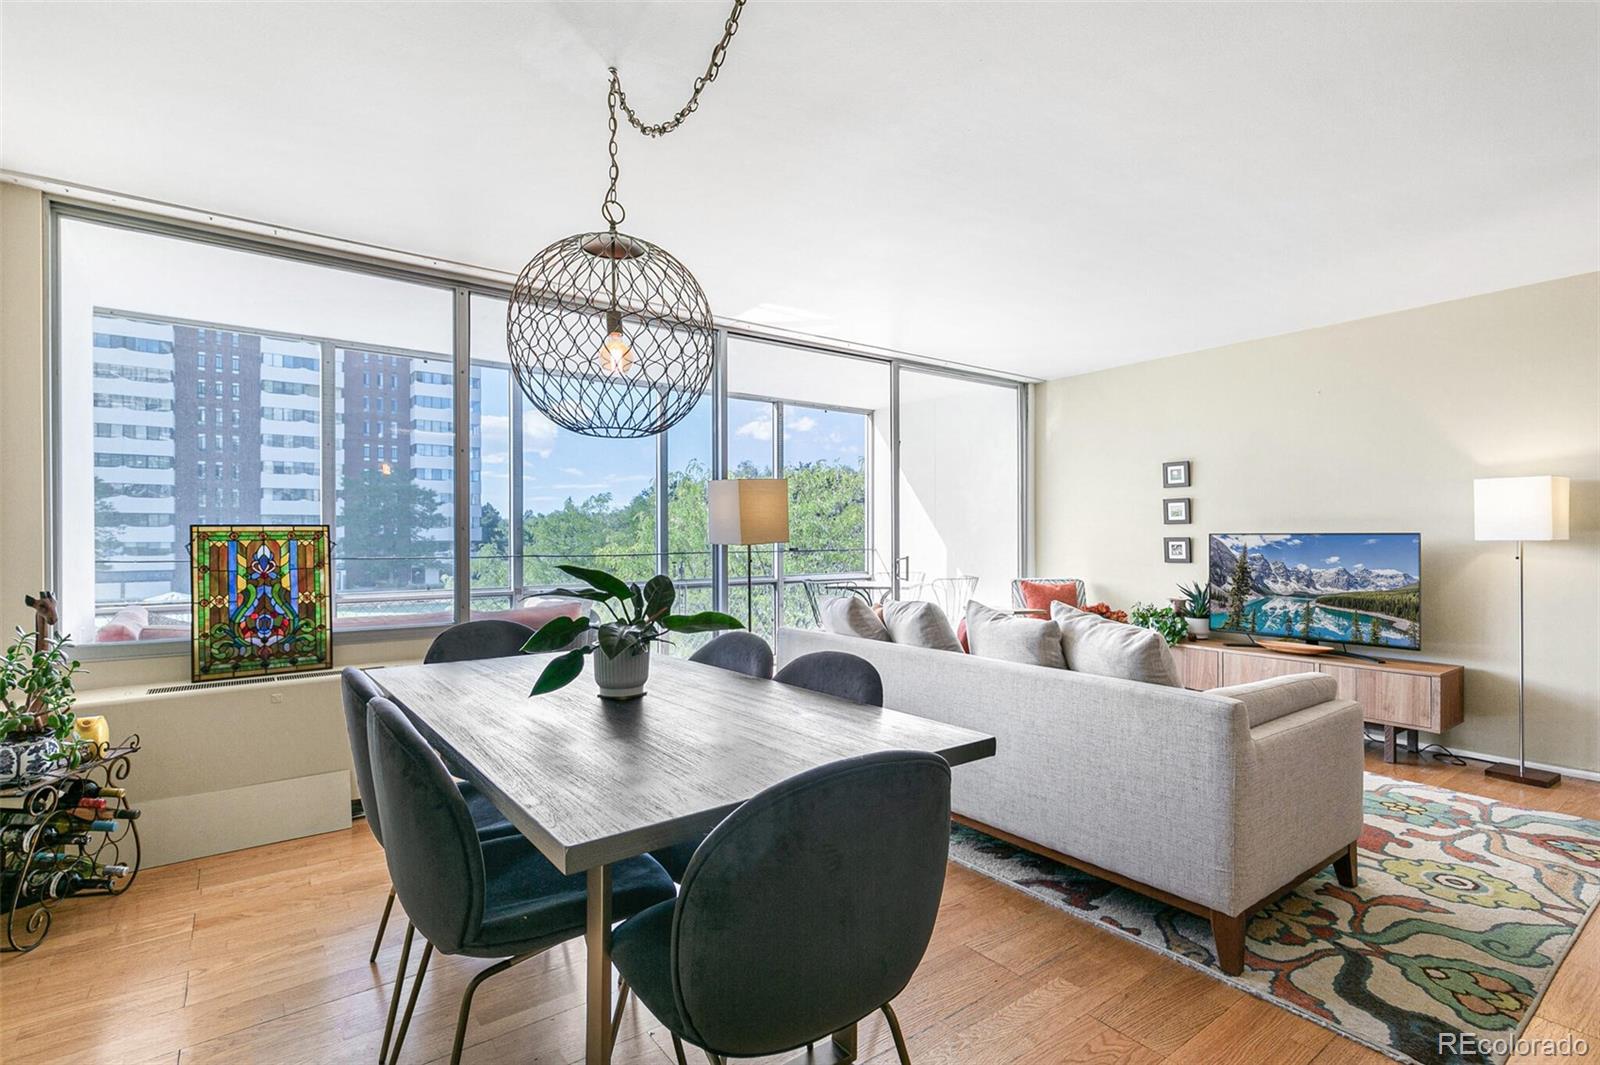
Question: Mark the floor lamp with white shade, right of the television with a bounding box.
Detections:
[1472,477,1570,788]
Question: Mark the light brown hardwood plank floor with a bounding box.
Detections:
[0,755,1600,1065]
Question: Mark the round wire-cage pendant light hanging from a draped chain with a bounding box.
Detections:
[506,0,746,438]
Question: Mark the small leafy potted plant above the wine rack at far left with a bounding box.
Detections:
[0,628,82,784]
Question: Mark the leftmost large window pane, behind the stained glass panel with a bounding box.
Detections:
[54,217,454,643]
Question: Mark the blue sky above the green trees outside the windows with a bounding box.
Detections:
[480,369,866,513]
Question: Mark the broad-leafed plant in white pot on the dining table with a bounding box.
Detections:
[522,566,744,699]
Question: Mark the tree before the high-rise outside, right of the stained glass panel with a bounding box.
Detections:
[336,470,450,590]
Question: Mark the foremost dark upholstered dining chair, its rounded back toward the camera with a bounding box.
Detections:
[604,752,950,1065]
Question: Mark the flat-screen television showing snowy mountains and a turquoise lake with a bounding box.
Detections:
[1211,533,1422,651]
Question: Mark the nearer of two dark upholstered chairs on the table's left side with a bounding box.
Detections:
[366,696,672,1065]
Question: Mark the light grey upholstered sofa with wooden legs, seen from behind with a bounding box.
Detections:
[778,628,1362,974]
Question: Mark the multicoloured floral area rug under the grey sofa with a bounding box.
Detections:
[950,774,1600,1065]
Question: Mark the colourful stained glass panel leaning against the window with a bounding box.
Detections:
[189,525,333,681]
